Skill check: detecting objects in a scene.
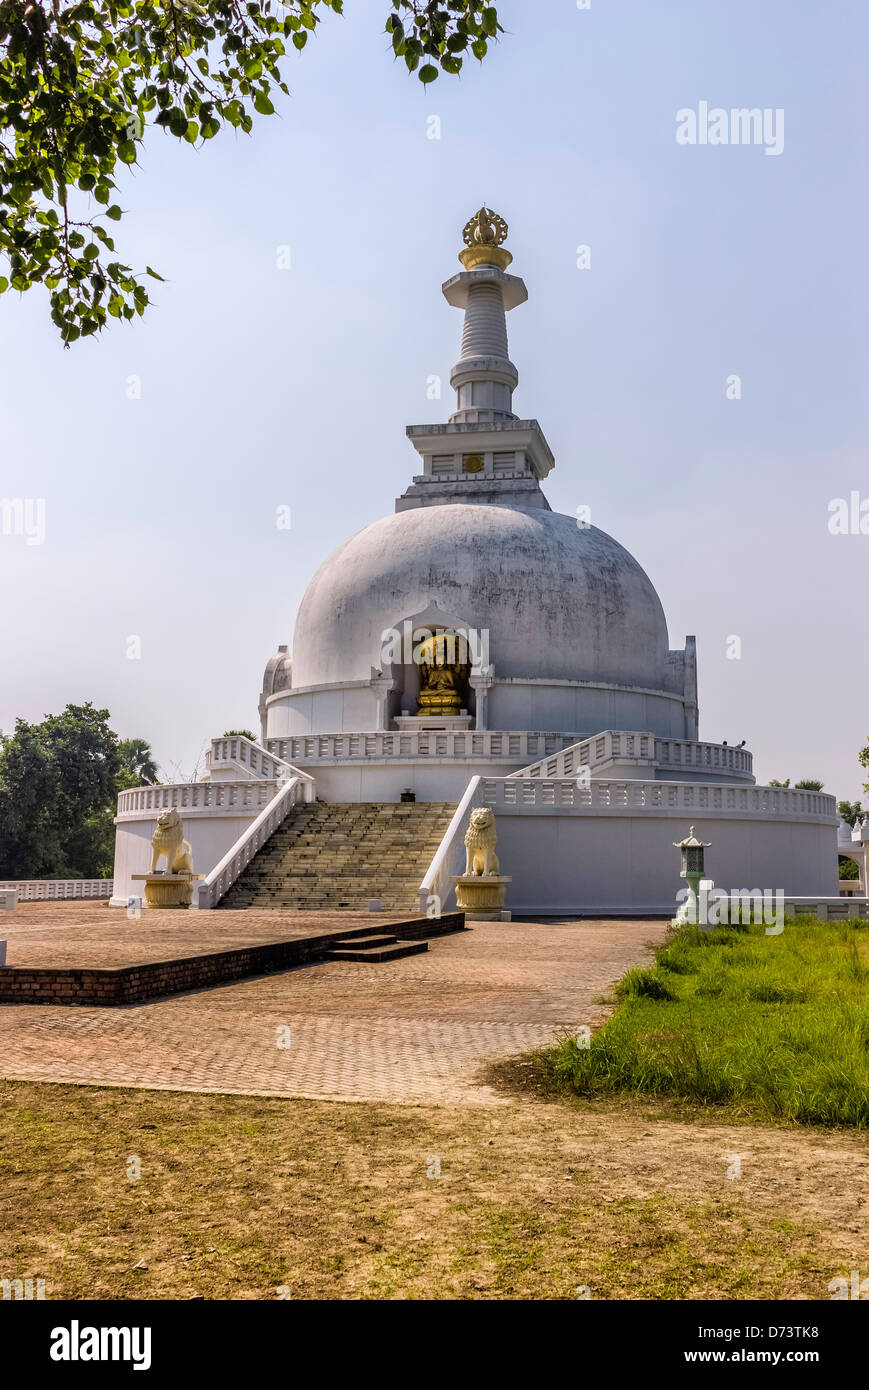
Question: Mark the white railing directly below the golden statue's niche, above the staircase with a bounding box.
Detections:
[266,728,576,766]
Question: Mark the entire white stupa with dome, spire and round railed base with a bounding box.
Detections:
[113,209,845,913]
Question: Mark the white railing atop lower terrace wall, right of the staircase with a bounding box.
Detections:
[480,777,838,823]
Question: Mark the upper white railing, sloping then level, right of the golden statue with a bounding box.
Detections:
[510,728,752,780]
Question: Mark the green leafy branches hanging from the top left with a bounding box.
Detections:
[0,0,499,345]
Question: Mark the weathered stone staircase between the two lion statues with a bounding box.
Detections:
[220,801,456,912]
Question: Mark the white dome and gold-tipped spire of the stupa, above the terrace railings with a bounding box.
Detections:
[261,209,697,794]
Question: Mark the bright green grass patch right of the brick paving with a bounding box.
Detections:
[552,917,869,1129]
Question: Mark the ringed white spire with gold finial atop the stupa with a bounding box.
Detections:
[444,207,528,424]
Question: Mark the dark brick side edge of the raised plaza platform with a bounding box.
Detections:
[0,912,464,1005]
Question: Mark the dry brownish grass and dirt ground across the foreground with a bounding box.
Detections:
[0,1062,869,1300]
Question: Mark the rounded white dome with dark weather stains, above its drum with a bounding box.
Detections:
[292,503,669,689]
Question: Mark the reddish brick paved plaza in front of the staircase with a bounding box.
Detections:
[0,904,666,1104]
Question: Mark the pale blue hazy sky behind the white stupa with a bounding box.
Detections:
[0,0,869,798]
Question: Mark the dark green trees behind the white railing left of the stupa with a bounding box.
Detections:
[0,702,157,878]
